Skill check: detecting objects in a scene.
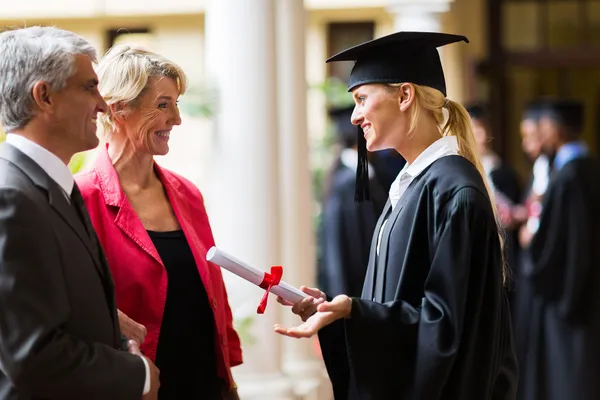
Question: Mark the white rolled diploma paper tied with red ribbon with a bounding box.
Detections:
[206,246,308,304]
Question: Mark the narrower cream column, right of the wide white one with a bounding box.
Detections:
[277,0,328,399]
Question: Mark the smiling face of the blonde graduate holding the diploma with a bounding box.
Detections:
[352,84,410,151]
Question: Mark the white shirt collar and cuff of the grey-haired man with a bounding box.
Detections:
[6,133,150,394]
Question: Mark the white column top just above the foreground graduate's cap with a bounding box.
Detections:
[388,0,452,32]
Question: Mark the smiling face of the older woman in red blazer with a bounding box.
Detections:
[120,77,181,155]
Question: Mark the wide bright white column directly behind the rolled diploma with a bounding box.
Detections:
[204,0,294,400]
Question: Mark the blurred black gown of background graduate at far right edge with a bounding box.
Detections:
[519,157,600,400]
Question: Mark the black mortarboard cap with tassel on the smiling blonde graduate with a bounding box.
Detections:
[327,32,469,202]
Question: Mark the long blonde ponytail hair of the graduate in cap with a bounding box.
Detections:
[388,83,510,284]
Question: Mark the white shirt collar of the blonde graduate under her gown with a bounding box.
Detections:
[377,136,458,255]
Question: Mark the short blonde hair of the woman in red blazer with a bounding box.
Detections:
[97,45,187,140]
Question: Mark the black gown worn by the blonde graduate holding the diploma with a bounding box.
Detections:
[319,156,518,400]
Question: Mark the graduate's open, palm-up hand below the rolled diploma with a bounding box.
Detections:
[273,294,352,338]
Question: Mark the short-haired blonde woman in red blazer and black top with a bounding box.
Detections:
[77,46,242,400]
